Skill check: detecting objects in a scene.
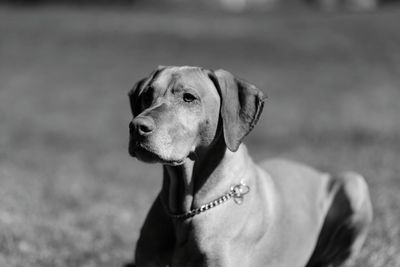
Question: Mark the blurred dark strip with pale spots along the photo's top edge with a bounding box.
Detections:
[0,0,400,12]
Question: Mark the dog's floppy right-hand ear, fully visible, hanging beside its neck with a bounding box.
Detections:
[209,70,264,152]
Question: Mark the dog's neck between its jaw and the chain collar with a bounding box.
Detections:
[161,139,251,217]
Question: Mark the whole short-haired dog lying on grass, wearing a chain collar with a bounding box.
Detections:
[129,66,372,267]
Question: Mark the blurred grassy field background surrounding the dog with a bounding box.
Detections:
[0,0,400,267]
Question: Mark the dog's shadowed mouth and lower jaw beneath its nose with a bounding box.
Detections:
[129,142,187,166]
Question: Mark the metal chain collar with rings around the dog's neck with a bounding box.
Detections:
[165,181,250,220]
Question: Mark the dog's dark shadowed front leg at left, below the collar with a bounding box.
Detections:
[134,196,175,267]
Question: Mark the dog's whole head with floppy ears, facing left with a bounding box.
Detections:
[129,66,263,165]
